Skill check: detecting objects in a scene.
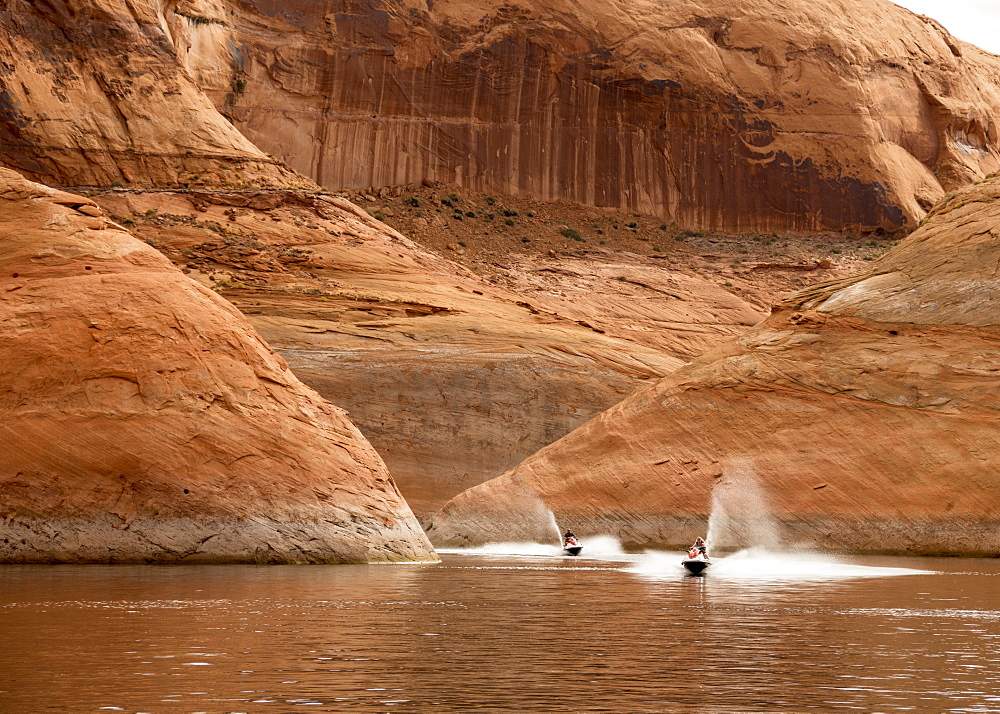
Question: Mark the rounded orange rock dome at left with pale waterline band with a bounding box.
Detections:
[0,170,434,563]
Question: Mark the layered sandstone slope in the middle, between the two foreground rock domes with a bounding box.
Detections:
[94,186,763,515]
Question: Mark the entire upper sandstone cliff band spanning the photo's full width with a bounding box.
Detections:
[0,0,1000,230]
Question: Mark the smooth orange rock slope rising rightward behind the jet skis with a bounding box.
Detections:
[430,179,1000,555]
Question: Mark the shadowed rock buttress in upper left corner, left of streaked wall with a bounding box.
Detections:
[0,0,300,186]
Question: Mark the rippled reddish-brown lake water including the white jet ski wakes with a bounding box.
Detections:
[0,540,1000,712]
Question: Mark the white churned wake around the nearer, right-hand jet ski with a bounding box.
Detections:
[627,548,930,582]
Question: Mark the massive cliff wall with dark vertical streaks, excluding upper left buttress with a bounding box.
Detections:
[193,0,1000,231]
